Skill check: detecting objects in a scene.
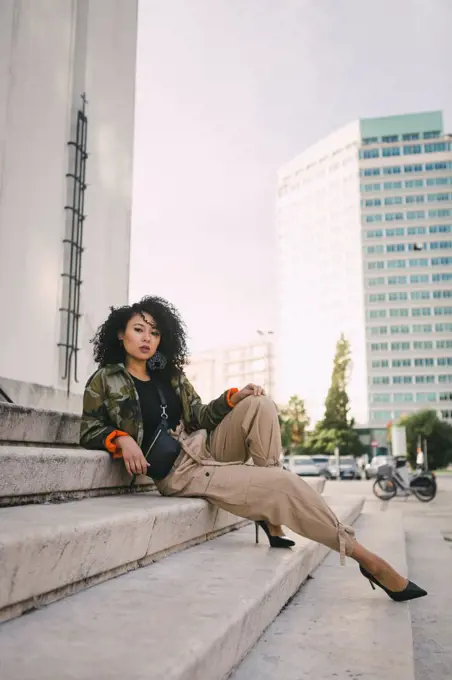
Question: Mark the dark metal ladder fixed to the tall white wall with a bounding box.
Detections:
[58,94,88,395]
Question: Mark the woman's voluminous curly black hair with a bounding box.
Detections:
[91,295,188,376]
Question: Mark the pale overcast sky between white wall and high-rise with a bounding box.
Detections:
[130,0,452,351]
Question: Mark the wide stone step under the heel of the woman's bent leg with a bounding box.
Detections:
[0,497,364,680]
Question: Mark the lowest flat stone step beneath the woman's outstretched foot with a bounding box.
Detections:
[231,504,414,680]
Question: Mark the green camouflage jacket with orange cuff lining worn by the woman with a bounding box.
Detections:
[80,364,236,453]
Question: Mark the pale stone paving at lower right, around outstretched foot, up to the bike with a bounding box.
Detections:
[231,476,452,680]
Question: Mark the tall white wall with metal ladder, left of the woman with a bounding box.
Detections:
[0,0,137,410]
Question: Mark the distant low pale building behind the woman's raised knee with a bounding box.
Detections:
[185,336,274,403]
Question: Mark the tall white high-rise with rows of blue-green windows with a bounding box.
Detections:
[277,112,452,426]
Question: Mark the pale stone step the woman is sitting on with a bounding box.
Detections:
[0,482,324,620]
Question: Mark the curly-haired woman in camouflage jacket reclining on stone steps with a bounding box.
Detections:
[80,297,427,601]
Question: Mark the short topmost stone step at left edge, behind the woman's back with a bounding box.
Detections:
[0,402,80,446]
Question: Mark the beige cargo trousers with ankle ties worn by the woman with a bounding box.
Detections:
[157,397,355,557]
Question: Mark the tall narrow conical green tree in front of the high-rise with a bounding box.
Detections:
[307,334,365,456]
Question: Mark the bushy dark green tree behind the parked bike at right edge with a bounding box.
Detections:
[400,410,452,470]
